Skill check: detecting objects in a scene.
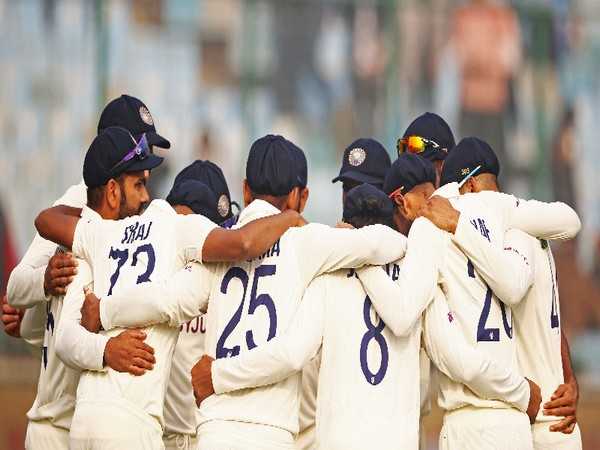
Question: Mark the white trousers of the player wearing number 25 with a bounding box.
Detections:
[198,420,295,450]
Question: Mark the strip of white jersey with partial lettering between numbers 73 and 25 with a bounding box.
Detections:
[165,314,206,436]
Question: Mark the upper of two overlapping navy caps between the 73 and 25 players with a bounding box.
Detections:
[173,159,232,223]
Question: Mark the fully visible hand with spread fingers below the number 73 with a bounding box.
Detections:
[104,329,156,376]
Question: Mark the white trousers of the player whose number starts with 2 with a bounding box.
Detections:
[440,407,533,450]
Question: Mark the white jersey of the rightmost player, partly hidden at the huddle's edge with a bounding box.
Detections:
[513,237,564,422]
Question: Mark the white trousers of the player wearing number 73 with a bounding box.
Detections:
[69,402,165,450]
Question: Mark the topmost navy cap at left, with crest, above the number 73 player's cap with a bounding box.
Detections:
[98,94,171,148]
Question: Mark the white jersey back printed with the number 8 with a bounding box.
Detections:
[316,263,421,449]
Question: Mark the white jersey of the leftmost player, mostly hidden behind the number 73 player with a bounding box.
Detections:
[7,182,88,430]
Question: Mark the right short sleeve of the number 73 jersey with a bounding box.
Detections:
[175,214,218,263]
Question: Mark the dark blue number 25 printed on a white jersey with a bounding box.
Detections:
[215,264,277,359]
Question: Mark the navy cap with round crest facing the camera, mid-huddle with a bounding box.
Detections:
[331,138,392,188]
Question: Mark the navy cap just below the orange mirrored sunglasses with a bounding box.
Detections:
[383,153,435,195]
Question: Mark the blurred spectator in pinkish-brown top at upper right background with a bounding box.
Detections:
[452,0,521,168]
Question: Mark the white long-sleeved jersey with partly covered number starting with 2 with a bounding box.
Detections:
[432,186,581,410]
